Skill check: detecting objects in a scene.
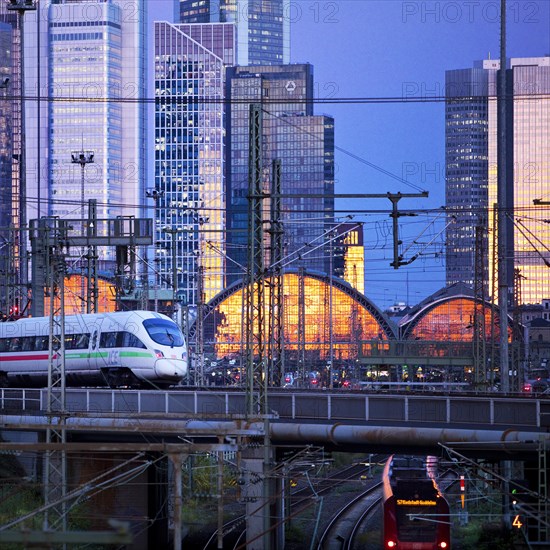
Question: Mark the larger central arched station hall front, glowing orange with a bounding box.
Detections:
[204,270,396,360]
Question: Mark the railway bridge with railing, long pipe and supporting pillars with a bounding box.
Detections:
[0,388,550,549]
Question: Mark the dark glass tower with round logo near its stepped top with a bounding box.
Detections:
[226,64,334,283]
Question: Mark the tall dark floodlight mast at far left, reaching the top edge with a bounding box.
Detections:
[3,0,36,316]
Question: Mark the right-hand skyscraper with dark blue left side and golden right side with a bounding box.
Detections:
[446,57,550,303]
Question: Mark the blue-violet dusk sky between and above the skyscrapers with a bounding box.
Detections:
[149,0,550,308]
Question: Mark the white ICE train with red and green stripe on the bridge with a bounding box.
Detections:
[0,311,188,387]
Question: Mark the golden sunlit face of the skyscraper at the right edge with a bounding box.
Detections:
[489,56,550,305]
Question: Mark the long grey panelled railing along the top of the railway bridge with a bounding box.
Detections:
[0,388,550,436]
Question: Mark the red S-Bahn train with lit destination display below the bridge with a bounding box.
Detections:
[382,456,451,550]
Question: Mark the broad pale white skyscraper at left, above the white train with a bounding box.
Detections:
[25,0,147,260]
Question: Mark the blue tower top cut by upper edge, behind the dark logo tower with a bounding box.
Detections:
[180,0,291,65]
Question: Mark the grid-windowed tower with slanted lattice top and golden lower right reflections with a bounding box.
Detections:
[155,22,236,305]
